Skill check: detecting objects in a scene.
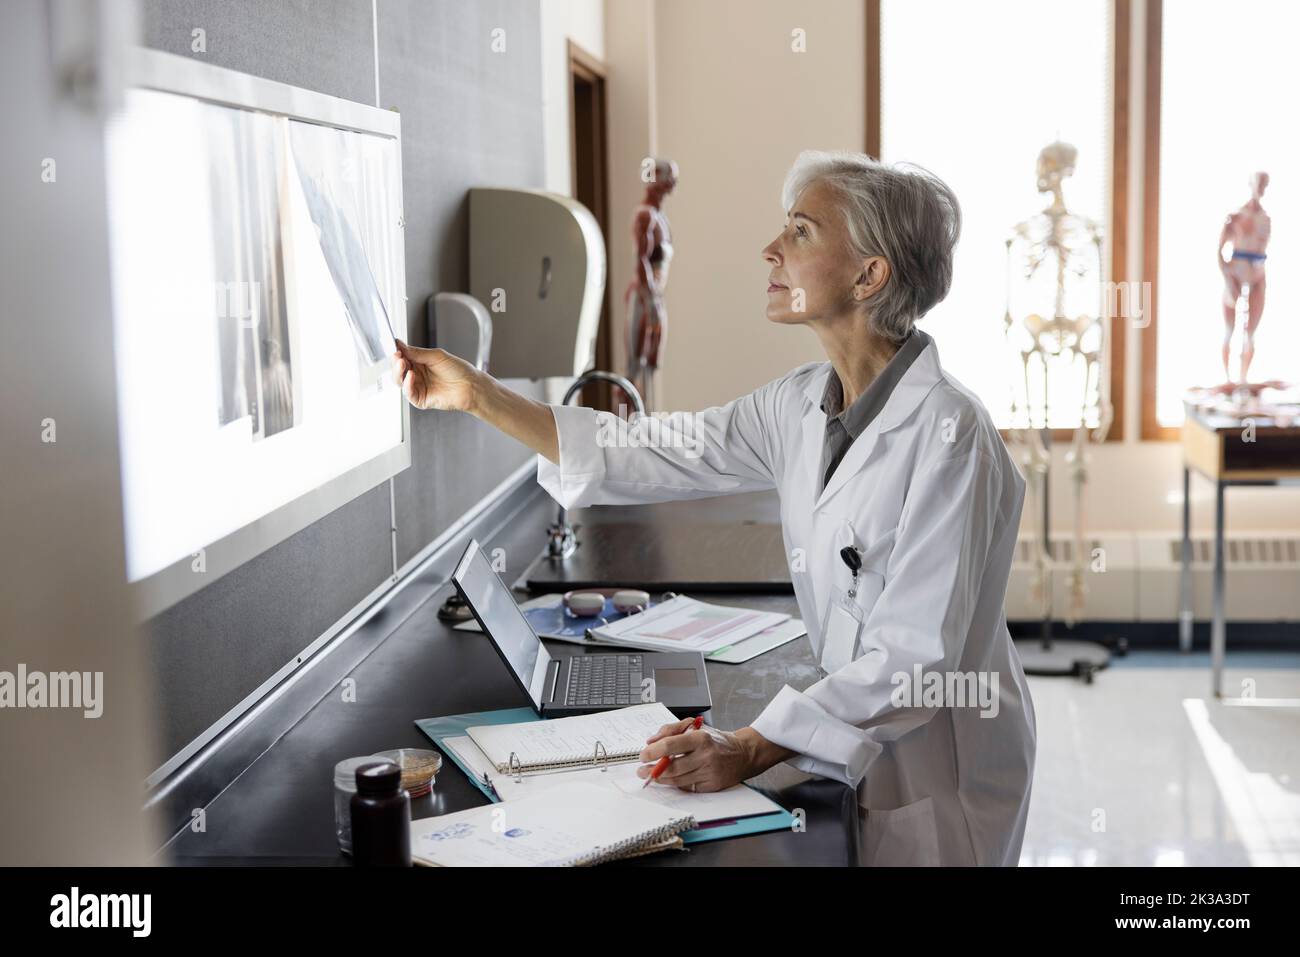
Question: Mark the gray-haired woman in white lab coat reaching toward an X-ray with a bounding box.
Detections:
[394,152,1036,865]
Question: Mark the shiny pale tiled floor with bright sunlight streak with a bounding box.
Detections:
[1021,651,1300,866]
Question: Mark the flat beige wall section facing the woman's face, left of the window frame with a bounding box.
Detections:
[654,0,866,408]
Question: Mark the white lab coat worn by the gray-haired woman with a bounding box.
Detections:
[537,342,1036,865]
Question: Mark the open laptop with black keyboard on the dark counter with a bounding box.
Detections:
[451,541,712,718]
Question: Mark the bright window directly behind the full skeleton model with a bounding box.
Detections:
[880,0,1112,428]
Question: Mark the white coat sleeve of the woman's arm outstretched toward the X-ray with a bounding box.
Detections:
[537,380,783,508]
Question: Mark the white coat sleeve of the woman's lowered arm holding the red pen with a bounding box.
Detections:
[753,449,1005,787]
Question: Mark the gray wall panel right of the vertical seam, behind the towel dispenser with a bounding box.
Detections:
[378,0,545,564]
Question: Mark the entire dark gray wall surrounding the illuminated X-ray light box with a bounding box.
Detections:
[144,0,543,757]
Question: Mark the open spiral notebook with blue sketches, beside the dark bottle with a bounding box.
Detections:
[411,784,696,867]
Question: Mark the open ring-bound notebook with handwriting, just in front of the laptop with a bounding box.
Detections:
[465,702,677,774]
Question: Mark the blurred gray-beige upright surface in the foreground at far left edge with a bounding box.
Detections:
[0,0,160,869]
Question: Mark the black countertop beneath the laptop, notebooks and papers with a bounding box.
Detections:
[164,492,858,866]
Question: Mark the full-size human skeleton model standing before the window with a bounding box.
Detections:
[1004,143,1112,624]
